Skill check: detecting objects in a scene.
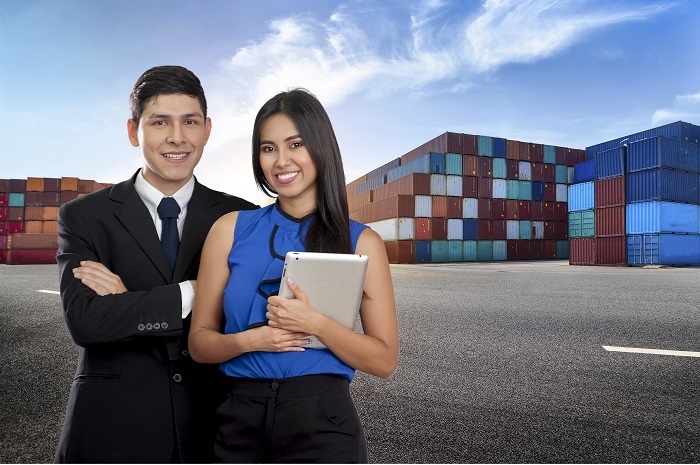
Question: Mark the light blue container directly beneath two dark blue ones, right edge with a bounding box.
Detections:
[626,201,700,234]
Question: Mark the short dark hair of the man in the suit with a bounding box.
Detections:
[129,66,207,124]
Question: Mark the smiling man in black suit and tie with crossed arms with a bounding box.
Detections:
[56,66,256,463]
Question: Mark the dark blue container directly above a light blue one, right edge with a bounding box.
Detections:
[625,168,700,205]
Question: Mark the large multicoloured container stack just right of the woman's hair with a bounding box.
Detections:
[347,132,585,263]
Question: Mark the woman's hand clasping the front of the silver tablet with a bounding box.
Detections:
[266,278,324,335]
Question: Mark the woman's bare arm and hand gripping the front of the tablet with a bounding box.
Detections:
[268,229,399,378]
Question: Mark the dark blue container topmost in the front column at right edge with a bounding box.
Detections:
[627,136,700,173]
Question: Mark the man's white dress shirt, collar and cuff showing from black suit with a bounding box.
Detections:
[134,171,194,320]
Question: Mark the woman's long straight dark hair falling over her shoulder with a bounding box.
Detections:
[253,89,354,253]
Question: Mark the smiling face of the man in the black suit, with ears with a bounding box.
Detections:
[127,94,211,196]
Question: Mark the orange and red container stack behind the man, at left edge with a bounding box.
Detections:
[0,178,107,265]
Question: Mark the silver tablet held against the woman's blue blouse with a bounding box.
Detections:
[279,252,369,349]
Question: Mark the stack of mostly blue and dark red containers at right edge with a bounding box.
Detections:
[569,122,700,266]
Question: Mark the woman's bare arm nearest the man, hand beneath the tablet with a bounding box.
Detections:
[188,212,306,363]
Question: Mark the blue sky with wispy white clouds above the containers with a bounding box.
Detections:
[0,0,700,203]
